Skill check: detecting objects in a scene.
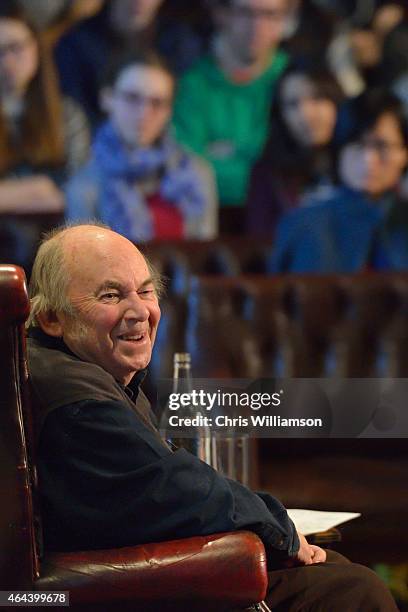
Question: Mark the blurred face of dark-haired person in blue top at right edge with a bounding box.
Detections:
[339,112,408,198]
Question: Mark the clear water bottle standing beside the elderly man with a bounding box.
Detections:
[160,353,212,465]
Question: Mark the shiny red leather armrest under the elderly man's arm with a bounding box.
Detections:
[35,531,267,609]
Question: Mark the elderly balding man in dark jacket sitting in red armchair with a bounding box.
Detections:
[28,225,396,612]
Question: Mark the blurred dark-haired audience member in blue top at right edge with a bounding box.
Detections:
[270,91,408,272]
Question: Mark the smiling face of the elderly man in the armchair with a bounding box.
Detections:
[55,228,160,384]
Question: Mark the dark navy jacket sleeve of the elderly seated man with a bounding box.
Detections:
[38,401,299,565]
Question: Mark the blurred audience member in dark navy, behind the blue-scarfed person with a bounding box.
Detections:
[56,0,204,125]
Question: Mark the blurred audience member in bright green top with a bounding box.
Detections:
[174,0,288,225]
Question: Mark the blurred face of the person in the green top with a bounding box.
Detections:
[219,0,288,63]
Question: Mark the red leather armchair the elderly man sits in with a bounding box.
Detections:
[0,265,267,612]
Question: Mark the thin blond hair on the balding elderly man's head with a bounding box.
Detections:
[26,221,165,328]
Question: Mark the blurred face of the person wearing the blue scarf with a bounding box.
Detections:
[103,64,173,148]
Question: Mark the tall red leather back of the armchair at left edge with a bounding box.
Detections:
[0,264,38,590]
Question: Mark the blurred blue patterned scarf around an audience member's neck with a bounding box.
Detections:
[93,121,206,242]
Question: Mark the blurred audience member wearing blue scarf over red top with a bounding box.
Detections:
[66,52,217,241]
